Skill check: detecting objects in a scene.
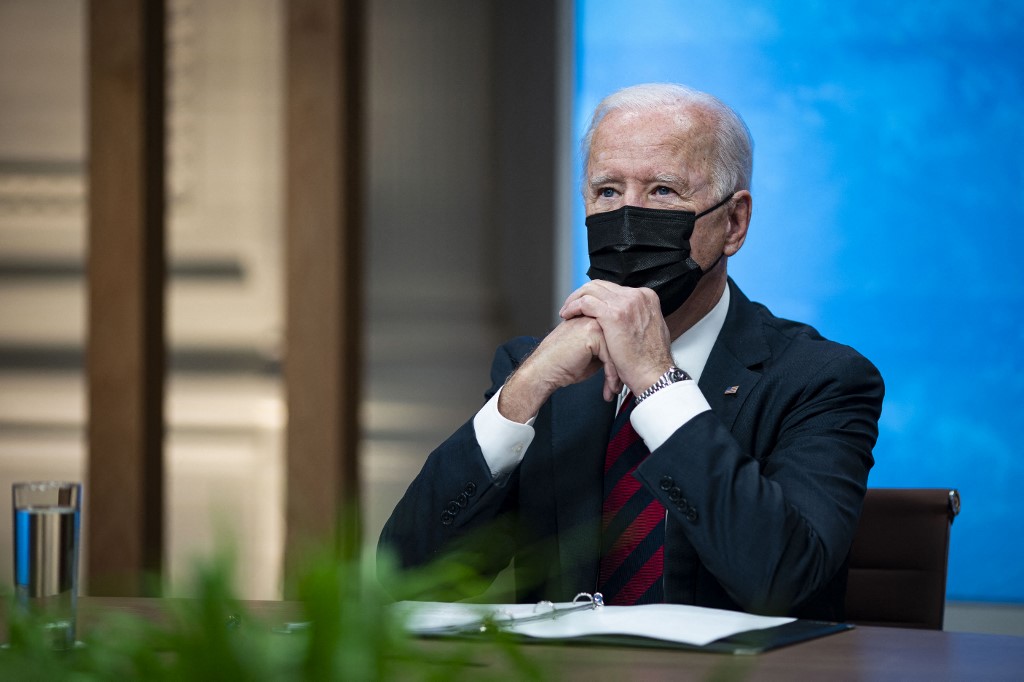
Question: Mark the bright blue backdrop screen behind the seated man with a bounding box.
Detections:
[573,0,1024,602]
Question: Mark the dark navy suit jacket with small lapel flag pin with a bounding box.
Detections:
[380,281,884,621]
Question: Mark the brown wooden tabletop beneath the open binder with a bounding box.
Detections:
[12,597,1024,682]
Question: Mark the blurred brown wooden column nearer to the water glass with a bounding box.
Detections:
[85,0,165,595]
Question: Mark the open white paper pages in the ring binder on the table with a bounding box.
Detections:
[395,601,796,646]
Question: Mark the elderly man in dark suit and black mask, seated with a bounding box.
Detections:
[380,84,884,620]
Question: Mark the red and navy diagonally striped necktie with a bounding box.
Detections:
[598,393,665,605]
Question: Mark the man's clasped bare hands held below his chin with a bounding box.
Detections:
[498,280,673,423]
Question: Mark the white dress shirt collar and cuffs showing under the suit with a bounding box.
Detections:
[473,287,729,478]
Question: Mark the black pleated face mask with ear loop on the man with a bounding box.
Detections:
[587,194,732,316]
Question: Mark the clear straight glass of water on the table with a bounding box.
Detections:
[12,481,82,649]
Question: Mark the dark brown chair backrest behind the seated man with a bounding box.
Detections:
[846,488,959,630]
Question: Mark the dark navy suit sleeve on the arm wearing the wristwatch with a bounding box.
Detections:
[637,346,884,613]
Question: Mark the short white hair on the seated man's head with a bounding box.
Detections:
[581,83,754,197]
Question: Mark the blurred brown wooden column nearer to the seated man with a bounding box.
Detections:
[285,0,365,578]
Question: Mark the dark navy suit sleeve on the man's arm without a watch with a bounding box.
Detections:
[378,337,536,579]
